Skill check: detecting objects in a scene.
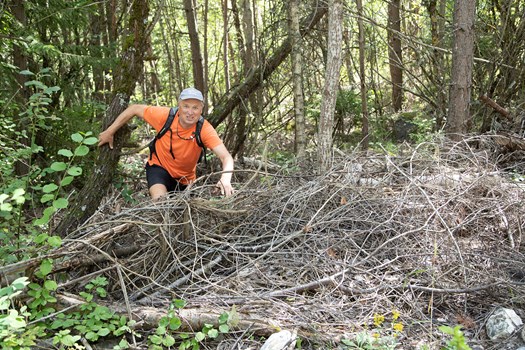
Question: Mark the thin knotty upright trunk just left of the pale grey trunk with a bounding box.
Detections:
[288,0,306,162]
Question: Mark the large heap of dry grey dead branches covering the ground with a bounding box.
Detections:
[42,136,525,349]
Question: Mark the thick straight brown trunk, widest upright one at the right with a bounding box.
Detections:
[446,0,476,140]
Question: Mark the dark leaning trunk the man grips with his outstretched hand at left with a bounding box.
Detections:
[55,0,149,237]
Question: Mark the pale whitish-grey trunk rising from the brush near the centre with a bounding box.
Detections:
[317,0,343,171]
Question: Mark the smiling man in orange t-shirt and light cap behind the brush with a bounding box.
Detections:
[98,88,233,199]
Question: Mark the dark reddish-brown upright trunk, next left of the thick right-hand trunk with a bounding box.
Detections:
[388,0,403,112]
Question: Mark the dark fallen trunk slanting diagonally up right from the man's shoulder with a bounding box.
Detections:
[208,3,327,126]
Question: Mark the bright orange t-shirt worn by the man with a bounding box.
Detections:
[144,106,222,185]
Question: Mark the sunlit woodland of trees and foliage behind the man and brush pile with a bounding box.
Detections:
[0,0,525,348]
